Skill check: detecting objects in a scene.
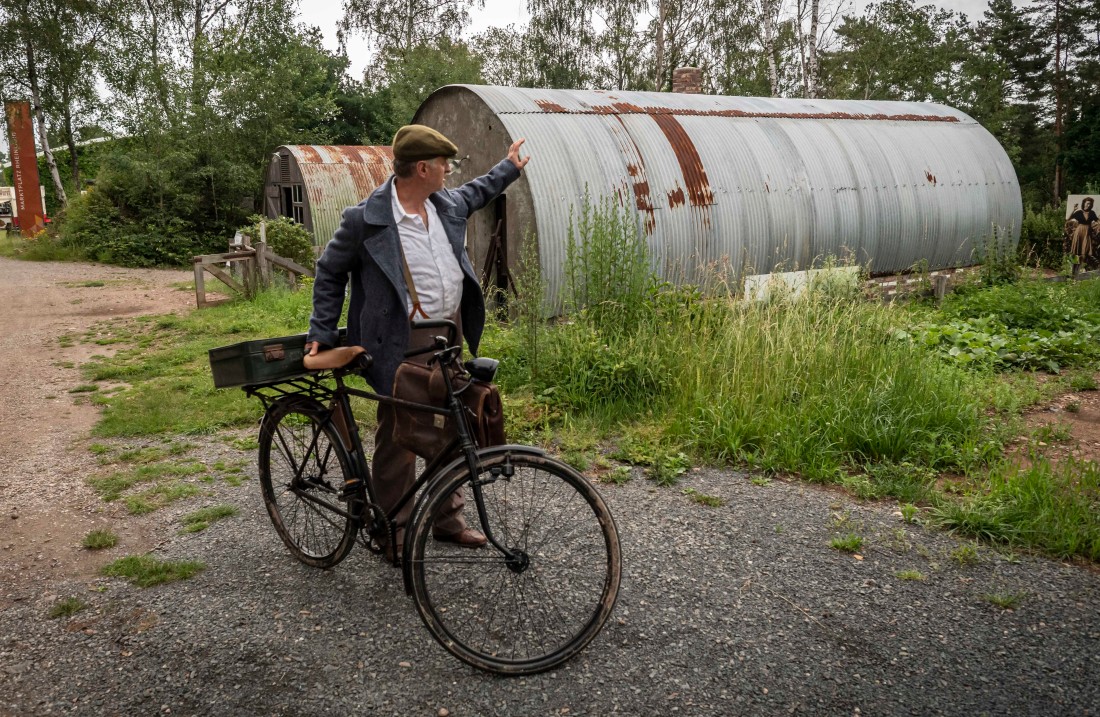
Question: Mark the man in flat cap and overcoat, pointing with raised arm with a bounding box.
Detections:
[306,124,530,556]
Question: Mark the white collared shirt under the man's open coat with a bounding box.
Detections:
[391,179,462,319]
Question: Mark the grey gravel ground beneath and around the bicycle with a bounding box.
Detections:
[0,256,1100,717]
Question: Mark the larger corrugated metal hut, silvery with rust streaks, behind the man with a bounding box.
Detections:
[414,85,1022,297]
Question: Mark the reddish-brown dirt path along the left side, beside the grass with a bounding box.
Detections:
[0,257,195,608]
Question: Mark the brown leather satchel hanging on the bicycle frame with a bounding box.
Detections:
[394,361,507,459]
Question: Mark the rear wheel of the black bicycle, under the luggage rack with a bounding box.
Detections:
[259,396,362,567]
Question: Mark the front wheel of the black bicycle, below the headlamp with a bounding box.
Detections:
[409,453,622,675]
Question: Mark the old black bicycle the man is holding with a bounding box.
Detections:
[211,320,622,675]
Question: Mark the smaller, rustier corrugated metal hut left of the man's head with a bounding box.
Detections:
[264,144,394,247]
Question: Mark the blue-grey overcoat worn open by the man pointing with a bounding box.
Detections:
[306,159,519,396]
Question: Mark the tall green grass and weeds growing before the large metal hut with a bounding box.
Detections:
[492,194,998,479]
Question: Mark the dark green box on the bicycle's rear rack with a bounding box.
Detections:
[208,329,347,388]
